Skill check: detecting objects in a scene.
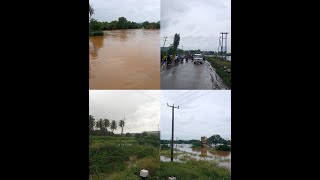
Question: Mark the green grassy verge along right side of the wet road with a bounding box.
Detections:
[206,57,231,89]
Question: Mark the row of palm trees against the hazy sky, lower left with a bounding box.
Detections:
[89,114,125,135]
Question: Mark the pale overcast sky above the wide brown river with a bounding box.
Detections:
[89,0,160,22]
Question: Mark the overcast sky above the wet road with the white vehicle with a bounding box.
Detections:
[160,0,231,52]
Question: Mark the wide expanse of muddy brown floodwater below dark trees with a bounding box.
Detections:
[89,29,160,89]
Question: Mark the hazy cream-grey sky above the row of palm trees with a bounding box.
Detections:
[89,90,160,133]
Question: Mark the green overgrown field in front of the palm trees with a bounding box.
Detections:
[89,136,160,180]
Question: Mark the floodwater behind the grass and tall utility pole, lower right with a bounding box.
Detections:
[160,144,231,169]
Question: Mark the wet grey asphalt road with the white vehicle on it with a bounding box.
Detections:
[161,60,228,90]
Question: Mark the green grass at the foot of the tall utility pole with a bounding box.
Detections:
[159,160,231,180]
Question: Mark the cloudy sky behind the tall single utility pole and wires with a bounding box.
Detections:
[160,90,231,140]
